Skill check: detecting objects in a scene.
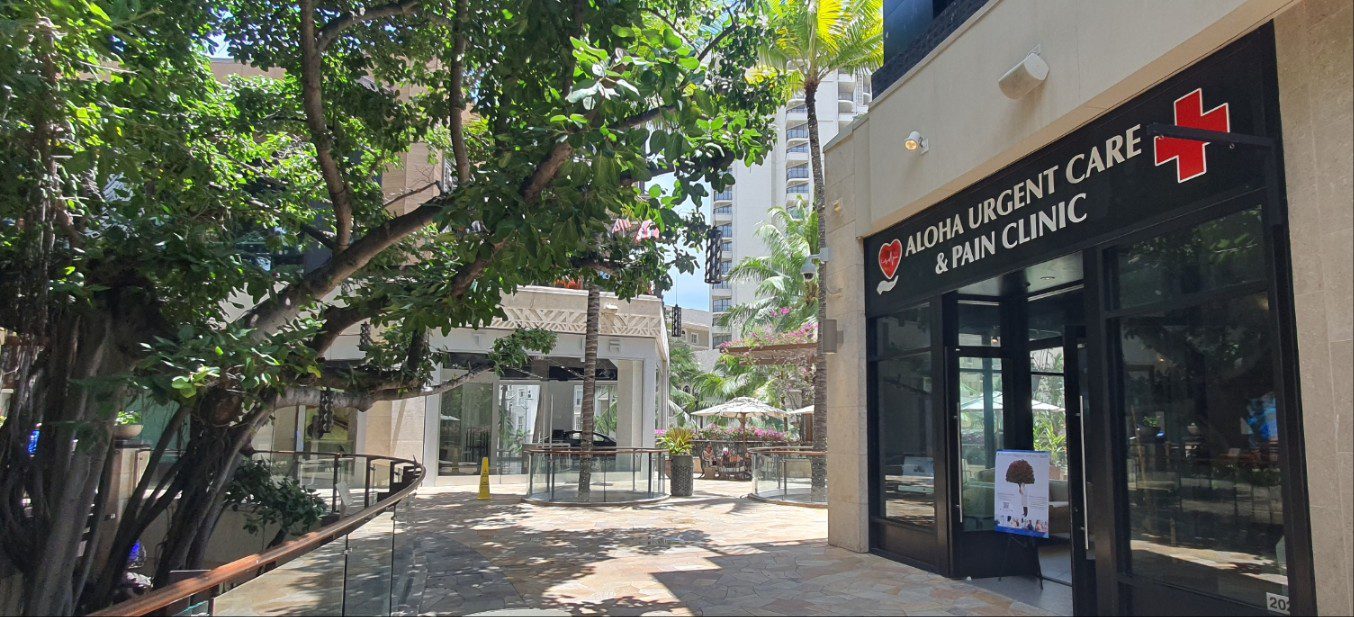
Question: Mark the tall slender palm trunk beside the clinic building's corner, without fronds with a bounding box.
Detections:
[804,80,827,501]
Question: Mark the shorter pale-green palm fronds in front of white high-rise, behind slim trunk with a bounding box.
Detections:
[723,200,819,336]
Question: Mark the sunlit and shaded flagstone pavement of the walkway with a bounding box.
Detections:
[409,480,1047,616]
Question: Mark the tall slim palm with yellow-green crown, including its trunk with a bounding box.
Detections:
[764,0,884,497]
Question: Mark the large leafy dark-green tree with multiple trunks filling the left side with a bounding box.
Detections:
[0,0,774,614]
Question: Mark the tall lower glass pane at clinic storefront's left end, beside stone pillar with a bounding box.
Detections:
[877,353,937,526]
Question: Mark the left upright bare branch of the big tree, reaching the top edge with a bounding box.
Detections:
[301,0,353,250]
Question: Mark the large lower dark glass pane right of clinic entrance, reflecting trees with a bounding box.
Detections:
[1118,292,1288,606]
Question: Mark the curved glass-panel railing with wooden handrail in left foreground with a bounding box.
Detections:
[91,451,425,616]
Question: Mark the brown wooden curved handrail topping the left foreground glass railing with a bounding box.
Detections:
[89,451,427,617]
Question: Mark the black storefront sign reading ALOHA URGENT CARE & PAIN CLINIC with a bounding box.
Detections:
[865,39,1270,315]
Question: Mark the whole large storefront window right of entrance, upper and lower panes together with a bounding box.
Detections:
[1105,207,1292,613]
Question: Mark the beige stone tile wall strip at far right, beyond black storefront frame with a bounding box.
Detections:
[1274,0,1354,614]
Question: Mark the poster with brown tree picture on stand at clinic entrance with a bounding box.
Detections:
[992,451,1049,537]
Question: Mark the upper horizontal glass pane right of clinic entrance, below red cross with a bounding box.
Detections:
[1116,208,1265,309]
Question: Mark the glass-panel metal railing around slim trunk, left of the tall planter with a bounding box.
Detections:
[523,444,668,506]
